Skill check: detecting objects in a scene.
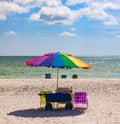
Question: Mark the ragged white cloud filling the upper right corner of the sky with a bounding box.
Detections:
[66,0,120,25]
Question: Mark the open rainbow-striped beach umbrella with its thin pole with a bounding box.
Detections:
[26,52,91,87]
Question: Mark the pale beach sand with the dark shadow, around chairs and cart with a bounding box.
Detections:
[0,78,120,124]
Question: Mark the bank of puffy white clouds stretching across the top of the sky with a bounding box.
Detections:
[0,0,120,25]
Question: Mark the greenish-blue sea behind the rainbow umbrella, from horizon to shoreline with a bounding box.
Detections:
[0,56,120,79]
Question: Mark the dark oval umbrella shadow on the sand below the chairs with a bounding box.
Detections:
[7,109,84,118]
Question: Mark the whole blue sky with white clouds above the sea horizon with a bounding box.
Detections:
[0,0,120,56]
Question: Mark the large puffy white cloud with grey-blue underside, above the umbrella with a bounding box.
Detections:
[30,6,77,25]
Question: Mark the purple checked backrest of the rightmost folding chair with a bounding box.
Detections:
[74,92,88,104]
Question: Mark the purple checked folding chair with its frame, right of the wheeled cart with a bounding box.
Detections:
[74,92,88,109]
